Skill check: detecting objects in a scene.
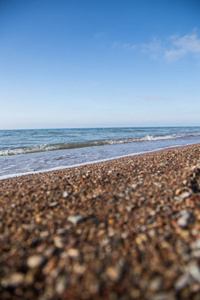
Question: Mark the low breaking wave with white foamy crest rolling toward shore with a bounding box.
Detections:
[0,132,200,156]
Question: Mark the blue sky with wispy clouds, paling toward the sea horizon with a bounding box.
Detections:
[0,0,200,129]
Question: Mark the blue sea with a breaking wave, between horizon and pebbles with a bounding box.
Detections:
[0,127,200,180]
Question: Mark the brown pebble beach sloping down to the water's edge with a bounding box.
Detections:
[0,144,200,300]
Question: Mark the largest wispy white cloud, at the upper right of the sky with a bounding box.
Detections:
[141,32,200,61]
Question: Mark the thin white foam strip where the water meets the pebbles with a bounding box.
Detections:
[0,143,198,181]
